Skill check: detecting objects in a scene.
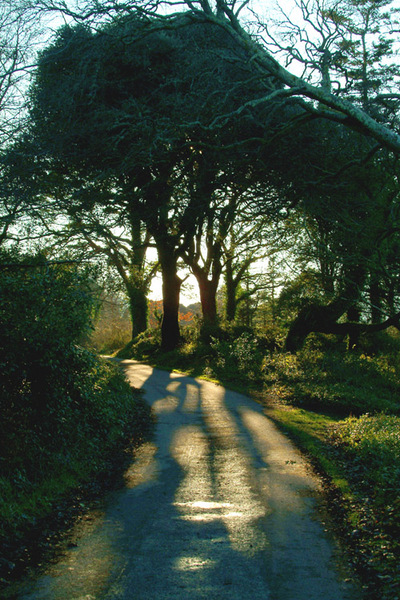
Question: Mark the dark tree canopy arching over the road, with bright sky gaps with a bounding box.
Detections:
[3,0,400,348]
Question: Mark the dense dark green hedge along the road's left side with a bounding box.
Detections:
[0,255,150,566]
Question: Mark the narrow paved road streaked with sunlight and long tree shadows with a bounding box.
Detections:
[10,361,361,600]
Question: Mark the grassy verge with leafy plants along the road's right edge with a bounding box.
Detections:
[267,406,400,600]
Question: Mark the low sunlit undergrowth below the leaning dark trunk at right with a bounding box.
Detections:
[263,347,400,415]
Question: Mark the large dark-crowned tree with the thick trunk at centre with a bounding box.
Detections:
[18,0,398,347]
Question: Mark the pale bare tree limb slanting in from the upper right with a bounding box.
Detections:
[21,0,400,153]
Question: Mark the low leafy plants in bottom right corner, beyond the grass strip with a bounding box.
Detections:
[333,414,400,600]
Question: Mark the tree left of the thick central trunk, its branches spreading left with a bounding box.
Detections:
[0,139,156,337]
